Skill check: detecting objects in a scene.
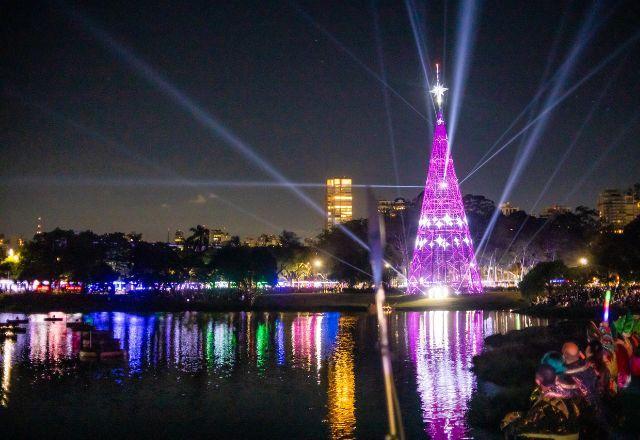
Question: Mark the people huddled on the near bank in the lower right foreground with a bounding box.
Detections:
[501,319,640,439]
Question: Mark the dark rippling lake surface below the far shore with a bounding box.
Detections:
[0,311,546,439]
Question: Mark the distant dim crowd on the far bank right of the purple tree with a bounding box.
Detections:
[533,285,640,310]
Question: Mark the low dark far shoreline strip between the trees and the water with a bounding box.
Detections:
[0,292,527,313]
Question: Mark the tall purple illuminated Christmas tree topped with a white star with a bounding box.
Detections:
[407,66,482,297]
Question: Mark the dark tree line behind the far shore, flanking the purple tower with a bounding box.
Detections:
[0,195,640,289]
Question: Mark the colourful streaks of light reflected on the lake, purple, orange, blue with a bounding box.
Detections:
[0,311,546,439]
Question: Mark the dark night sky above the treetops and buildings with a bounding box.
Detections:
[0,0,640,240]
